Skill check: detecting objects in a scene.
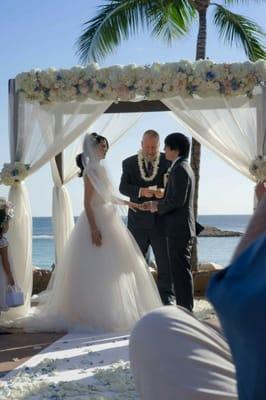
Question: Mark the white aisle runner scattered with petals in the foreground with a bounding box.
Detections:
[0,333,139,400]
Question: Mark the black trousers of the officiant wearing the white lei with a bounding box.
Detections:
[128,226,173,303]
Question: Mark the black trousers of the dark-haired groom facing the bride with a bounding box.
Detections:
[167,237,194,311]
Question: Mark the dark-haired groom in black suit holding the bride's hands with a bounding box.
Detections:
[142,133,196,311]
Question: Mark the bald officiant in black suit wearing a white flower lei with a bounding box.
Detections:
[119,129,172,304]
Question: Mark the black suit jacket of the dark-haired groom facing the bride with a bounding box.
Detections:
[158,158,195,239]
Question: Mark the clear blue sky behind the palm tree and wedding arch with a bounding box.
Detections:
[0,0,266,216]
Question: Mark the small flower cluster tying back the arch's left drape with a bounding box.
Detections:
[0,161,30,186]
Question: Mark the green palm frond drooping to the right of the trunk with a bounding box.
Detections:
[212,3,266,61]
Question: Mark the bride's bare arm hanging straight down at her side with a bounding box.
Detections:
[84,176,102,246]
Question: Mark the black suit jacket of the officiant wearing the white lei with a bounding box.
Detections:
[119,153,171,229]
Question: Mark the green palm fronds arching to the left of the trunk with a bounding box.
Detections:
[77,0,194,64]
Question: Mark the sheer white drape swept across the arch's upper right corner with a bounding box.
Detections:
[162,87,266,180]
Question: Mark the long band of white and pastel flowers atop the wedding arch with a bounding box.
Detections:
[16,60,266,104]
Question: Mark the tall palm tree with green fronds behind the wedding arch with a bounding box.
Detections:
[78,0,266,268]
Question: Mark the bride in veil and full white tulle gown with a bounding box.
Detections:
[17,133,162,332]
